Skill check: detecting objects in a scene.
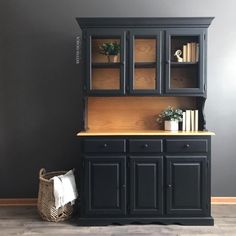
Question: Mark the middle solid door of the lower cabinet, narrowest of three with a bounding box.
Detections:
[130,156,163,215]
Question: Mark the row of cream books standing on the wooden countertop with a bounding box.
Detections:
[182,110,198,131]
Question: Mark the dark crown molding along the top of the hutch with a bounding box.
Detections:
[76,17,214,29]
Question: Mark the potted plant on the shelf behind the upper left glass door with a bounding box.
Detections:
[99,42,120,62]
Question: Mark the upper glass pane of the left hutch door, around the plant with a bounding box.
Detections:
[91,38,120,63]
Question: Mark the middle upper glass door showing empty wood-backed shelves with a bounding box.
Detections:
[129,29,162,95]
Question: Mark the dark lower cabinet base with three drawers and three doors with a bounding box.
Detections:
[79,137,213,225]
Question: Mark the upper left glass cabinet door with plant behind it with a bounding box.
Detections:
[86,29,126,95]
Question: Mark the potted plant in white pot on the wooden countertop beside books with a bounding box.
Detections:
[157,106,183,131]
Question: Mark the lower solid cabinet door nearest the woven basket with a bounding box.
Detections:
[84,156,126,216]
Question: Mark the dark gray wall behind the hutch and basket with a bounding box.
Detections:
[0,0,236,197]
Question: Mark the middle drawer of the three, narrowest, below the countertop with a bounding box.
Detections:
[129,139,163,153]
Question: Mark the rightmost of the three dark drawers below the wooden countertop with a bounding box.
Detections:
[166,139,208,153]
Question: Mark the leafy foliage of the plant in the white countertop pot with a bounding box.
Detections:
[157,106,183,124]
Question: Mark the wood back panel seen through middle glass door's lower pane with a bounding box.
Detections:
[134,68,156,90]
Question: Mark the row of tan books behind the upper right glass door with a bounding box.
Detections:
[183,42,199,62]
